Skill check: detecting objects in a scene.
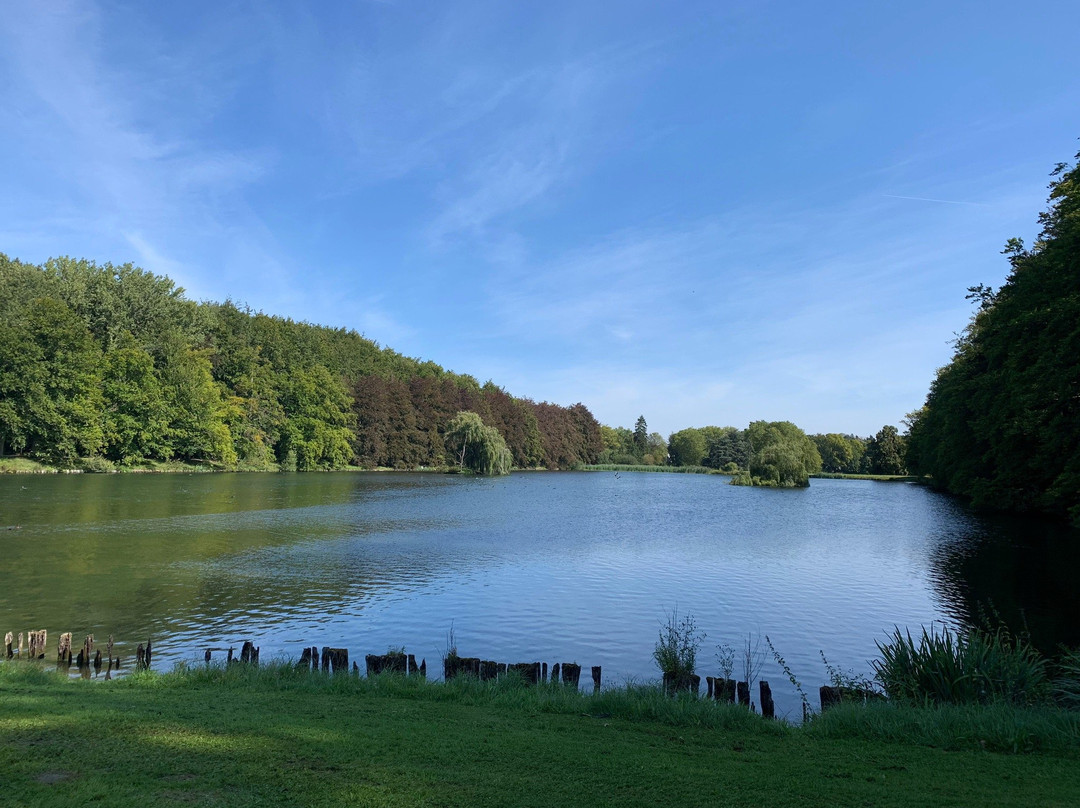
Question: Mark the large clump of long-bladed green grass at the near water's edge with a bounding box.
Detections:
[872,627,1051,704]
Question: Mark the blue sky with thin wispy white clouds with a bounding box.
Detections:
[0,0,1080,435]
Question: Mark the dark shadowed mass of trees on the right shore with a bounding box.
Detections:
[907,154,1080,521]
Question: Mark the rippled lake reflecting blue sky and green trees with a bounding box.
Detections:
[0,472,1080,716]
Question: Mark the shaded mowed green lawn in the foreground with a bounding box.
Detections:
[0,664,1080,808]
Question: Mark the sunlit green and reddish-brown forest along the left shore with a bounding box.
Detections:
[0,254,603,470]
